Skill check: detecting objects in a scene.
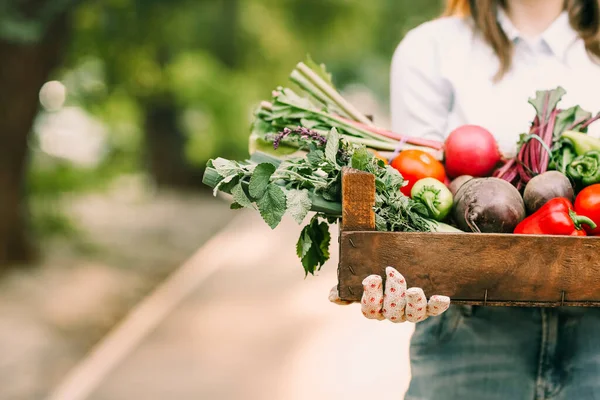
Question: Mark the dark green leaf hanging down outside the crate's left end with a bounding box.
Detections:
[296,215,331,275]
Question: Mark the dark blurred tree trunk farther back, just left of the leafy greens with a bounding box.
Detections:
[144,96,202,188]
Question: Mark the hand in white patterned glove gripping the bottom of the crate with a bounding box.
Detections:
[329,267,450,322]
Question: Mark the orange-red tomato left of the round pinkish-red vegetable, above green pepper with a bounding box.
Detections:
[390,150,446,196]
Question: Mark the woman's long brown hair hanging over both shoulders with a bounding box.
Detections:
[444,0,600,78]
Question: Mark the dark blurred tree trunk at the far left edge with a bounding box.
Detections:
[0,16,67,270]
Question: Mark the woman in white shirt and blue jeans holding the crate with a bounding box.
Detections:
[333,0,600,400]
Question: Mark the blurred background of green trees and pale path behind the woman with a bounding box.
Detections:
[0,0,443,400]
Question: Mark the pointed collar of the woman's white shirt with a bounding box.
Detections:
[497,8,578,60]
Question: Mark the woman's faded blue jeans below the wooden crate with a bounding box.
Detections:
[405,306,600,400]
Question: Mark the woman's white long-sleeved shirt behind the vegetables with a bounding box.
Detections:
[391,12,600,156]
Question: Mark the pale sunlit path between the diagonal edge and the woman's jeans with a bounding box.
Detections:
[76,213,413,400]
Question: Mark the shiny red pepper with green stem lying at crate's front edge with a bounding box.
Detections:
[514,197,596,236]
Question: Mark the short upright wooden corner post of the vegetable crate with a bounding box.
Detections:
[341,168,375,231]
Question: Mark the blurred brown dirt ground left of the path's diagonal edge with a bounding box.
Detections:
[0,191,235,400]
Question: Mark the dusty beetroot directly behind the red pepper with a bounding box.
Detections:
[523,171,575,214]
